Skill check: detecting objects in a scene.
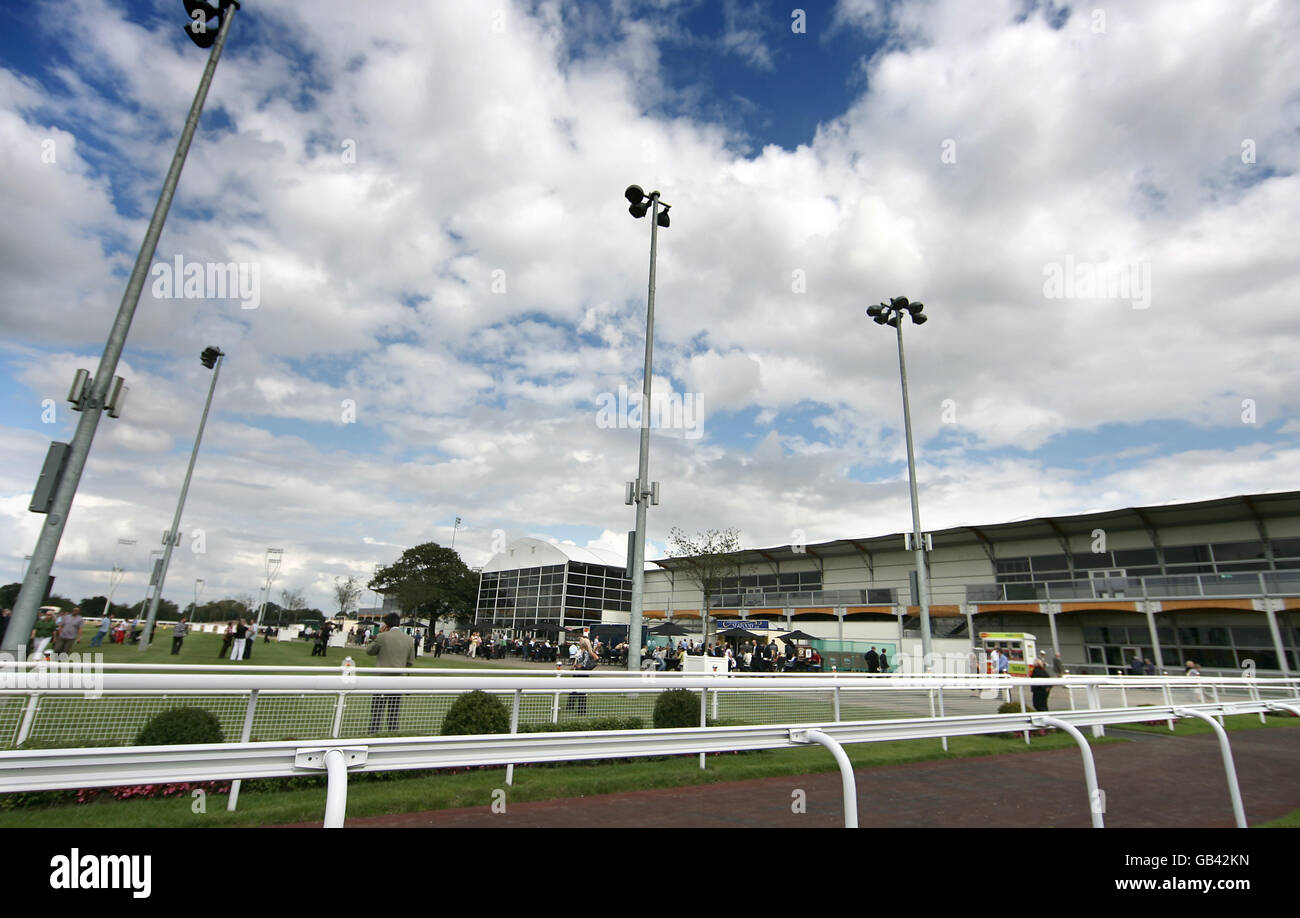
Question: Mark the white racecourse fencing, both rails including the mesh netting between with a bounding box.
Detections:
[0,664,1300,826]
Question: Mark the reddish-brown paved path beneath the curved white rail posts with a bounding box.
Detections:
[297,728,1300,828]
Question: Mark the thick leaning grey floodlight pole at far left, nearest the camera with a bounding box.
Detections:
[3,0,239,651]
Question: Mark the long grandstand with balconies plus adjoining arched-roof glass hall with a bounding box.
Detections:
[478,492,1300,675]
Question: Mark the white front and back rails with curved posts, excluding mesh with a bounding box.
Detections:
[0,664,1300,827]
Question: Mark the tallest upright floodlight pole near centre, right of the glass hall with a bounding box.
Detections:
[623,185,672,672]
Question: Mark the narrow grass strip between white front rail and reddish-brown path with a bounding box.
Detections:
[0,735,1107,828]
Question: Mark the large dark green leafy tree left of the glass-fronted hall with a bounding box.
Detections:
[369,542,478,628]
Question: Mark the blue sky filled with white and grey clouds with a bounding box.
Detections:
[0,0,1300,609]
